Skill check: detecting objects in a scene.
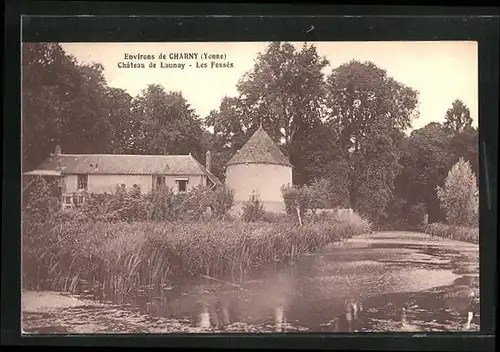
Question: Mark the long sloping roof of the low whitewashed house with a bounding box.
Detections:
[25,154,220,183]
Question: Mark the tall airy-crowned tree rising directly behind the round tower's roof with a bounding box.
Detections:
[238,42,328,148]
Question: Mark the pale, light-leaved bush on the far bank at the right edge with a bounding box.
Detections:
[437,158,478,226]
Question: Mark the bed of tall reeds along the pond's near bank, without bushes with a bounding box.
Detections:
[23,214,369,302]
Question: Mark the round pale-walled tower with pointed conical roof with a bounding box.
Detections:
[226,126,292,213]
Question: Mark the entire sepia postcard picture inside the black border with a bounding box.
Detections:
[20,41,480,334]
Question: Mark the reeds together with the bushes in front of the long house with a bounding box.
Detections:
[22,179,370,296]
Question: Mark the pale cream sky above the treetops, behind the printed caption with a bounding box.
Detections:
[61,41,478,128]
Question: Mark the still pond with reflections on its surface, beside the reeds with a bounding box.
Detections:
[23,232,479,332]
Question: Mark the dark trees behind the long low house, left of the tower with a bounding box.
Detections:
[22,43,203,171]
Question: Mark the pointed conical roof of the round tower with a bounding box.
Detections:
[227,126,292,167]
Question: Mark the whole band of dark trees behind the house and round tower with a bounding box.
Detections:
[22,42,478,228]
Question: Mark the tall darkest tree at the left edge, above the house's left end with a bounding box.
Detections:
[22,43,113,170]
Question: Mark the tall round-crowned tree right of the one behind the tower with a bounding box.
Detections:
[326,60,418,220]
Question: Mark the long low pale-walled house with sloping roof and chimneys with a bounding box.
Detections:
[24,146,220,208]
